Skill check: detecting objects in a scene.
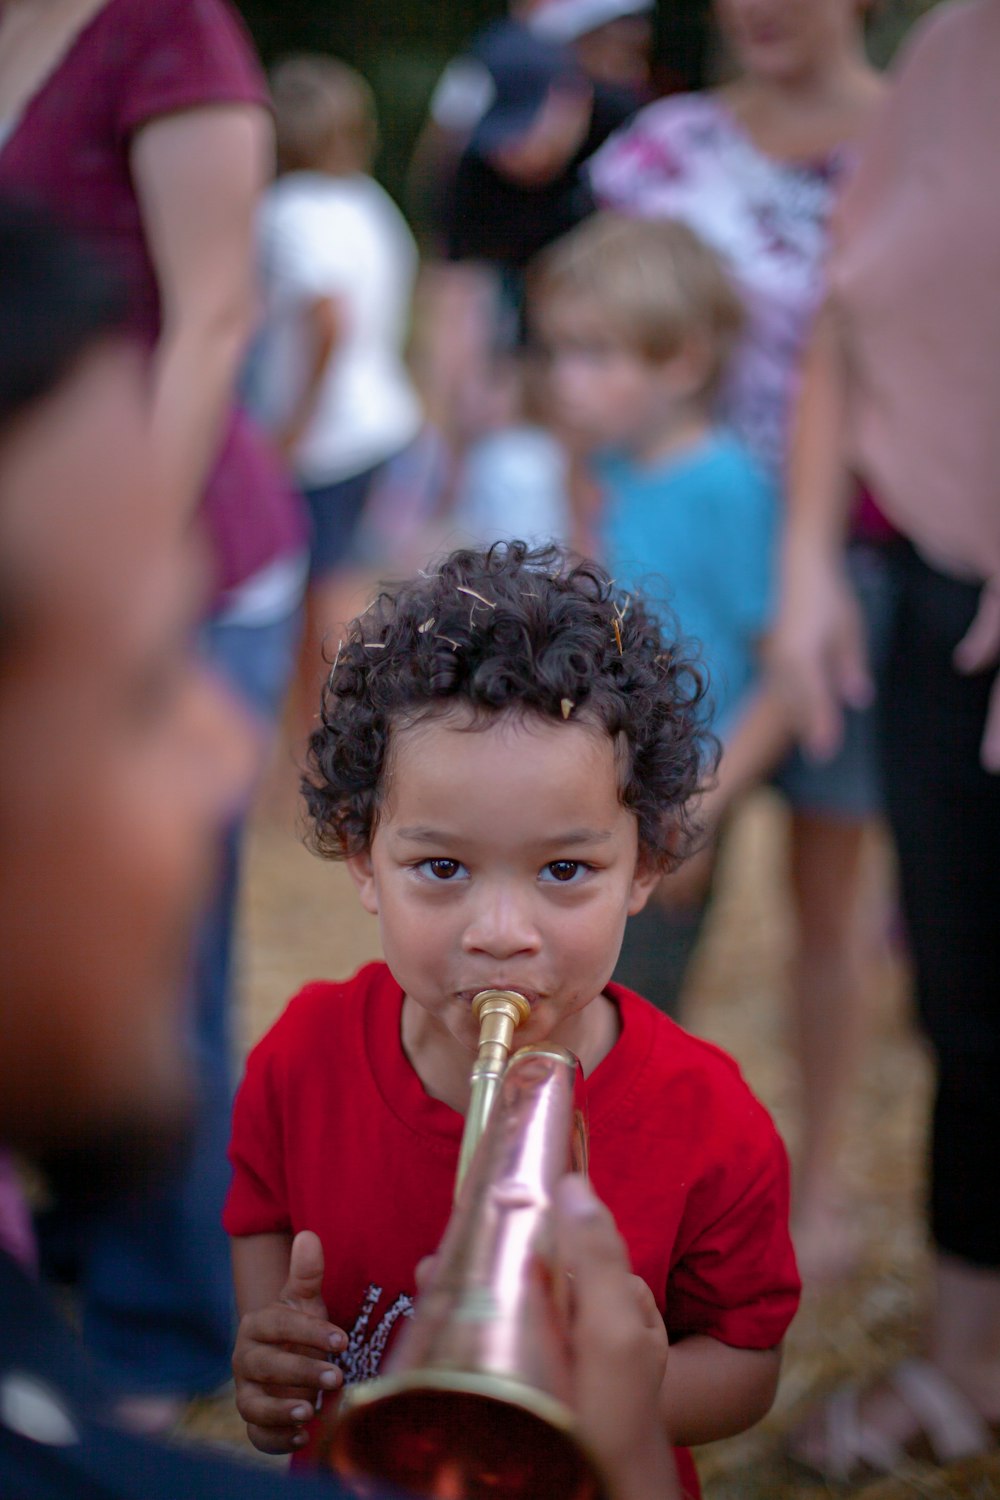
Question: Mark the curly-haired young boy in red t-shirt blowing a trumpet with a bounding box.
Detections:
[225,543,798,1494]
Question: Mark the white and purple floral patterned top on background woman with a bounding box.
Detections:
[589,93,855,479]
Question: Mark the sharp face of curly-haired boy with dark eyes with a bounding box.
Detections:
[349,714,657,1071]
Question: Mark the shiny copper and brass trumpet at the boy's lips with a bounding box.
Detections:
[327,990,606,1500]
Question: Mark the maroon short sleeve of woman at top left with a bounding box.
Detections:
[117,0,268,138]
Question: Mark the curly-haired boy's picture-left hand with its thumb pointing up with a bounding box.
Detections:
[232,1230,346,1454]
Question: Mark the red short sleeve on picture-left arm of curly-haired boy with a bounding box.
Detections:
[222,1032,291,1236]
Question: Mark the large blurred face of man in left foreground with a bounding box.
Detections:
[0,348,253,1157]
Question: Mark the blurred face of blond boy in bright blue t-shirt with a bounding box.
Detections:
[537,296,678,453]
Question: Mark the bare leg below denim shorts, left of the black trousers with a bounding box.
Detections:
[789,812,870,1281]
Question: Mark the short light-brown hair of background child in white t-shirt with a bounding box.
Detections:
[270,53,378,176]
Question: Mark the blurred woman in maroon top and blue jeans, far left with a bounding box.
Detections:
[0,0,306,1427]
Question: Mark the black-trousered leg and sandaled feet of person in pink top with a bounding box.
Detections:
[793,554,1000,1469]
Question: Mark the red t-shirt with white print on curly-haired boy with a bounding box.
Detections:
[223,963,799,1494]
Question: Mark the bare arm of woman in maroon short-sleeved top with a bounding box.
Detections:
[130,104,271,521]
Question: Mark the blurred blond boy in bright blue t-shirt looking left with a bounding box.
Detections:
[532,215,789,1013]
